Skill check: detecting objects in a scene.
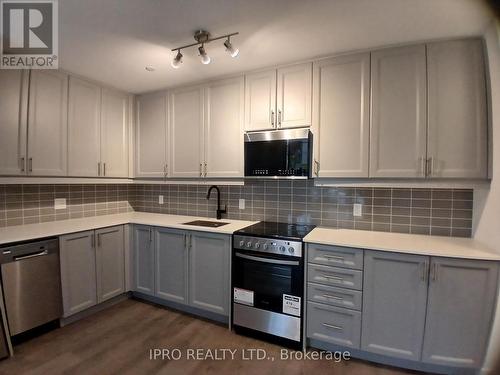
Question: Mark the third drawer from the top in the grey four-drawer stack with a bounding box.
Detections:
[307,283,363,311]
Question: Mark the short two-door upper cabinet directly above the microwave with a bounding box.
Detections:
[245,63,312,131]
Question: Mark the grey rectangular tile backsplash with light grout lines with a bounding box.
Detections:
[0,180,473,237]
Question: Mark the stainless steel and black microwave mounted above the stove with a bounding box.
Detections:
[245,129,313,179]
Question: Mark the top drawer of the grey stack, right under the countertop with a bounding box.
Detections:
[307,244,363,270]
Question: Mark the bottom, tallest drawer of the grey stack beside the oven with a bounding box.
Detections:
[306,302,361,348]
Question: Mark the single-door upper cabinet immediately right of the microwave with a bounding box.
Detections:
[313,53,370,177]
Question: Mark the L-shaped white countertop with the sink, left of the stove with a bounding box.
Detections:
[0,212,257,245]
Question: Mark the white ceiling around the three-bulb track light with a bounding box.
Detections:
[59,0,491,93]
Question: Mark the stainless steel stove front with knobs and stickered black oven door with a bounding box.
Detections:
[232,235,304,349]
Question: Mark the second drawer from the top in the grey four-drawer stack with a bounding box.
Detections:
[307,264,363,290]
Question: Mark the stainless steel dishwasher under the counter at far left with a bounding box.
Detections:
[0,239,62,336]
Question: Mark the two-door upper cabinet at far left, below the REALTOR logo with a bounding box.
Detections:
[0,70,68,176]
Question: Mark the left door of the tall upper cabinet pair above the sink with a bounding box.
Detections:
[169,86,205,177]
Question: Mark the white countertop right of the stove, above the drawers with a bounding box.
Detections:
[304,227,500,260]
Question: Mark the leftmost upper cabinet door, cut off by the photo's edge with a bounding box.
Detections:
[0,69,29,175]
